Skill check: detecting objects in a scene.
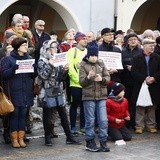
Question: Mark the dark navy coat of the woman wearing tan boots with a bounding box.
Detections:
[1,50,36,107]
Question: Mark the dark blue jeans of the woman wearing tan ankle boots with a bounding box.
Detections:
[10,106,27,132]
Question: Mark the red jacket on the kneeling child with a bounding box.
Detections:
[106,98,130,128]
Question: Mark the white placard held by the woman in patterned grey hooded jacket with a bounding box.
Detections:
[53,52,67,67]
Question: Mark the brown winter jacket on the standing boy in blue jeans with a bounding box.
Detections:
[79,58,110,100]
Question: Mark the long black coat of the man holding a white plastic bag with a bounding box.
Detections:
[131,53,160,105]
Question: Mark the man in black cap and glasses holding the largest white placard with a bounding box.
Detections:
[99,28,121,93]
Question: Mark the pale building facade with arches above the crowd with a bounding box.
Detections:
[0,0,160,37]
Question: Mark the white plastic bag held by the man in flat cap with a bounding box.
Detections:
[136,81,153,107]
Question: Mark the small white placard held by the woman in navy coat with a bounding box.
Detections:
[16,59,35,74]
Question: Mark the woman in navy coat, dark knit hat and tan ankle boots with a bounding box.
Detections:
[1,38,34,148]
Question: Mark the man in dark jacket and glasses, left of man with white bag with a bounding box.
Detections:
[120,33,143,128]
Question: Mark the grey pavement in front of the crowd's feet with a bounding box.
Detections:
[0,123,160,160]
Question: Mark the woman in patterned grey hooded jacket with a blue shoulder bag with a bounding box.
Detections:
[38,40,79,146]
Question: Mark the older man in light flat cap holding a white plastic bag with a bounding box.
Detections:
[131,39,160,134]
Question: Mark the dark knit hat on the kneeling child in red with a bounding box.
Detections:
[111,82,125,96]
